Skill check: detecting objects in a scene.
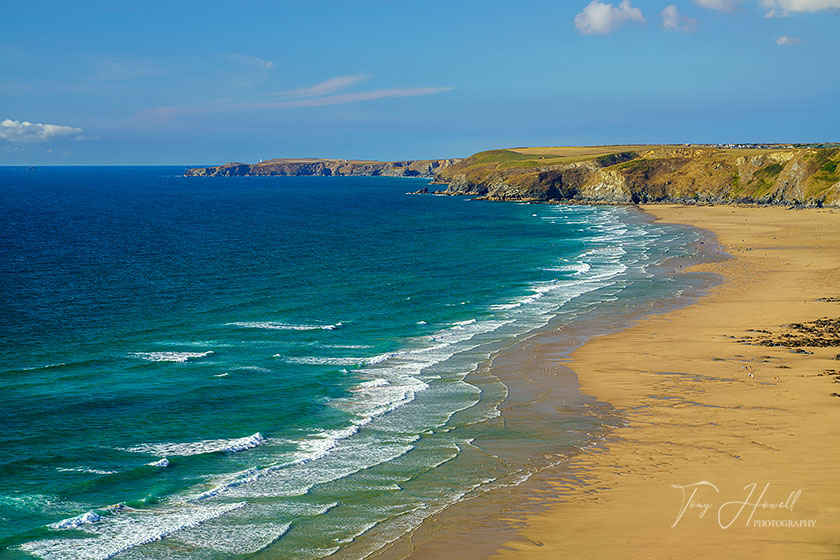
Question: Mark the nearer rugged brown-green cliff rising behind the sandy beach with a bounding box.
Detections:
[434,146,840,207]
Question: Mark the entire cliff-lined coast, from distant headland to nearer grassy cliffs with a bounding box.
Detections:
[185,143,840,207]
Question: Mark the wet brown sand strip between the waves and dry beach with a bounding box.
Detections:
[369,210,728,560]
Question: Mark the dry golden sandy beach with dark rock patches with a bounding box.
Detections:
[492,206,840,559]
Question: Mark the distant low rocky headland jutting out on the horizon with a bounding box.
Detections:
[184,159,460,177]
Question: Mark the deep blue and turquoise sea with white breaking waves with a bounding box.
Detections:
[0,167,700,560]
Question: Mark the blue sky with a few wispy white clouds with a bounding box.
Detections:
[0,0,840,165]
